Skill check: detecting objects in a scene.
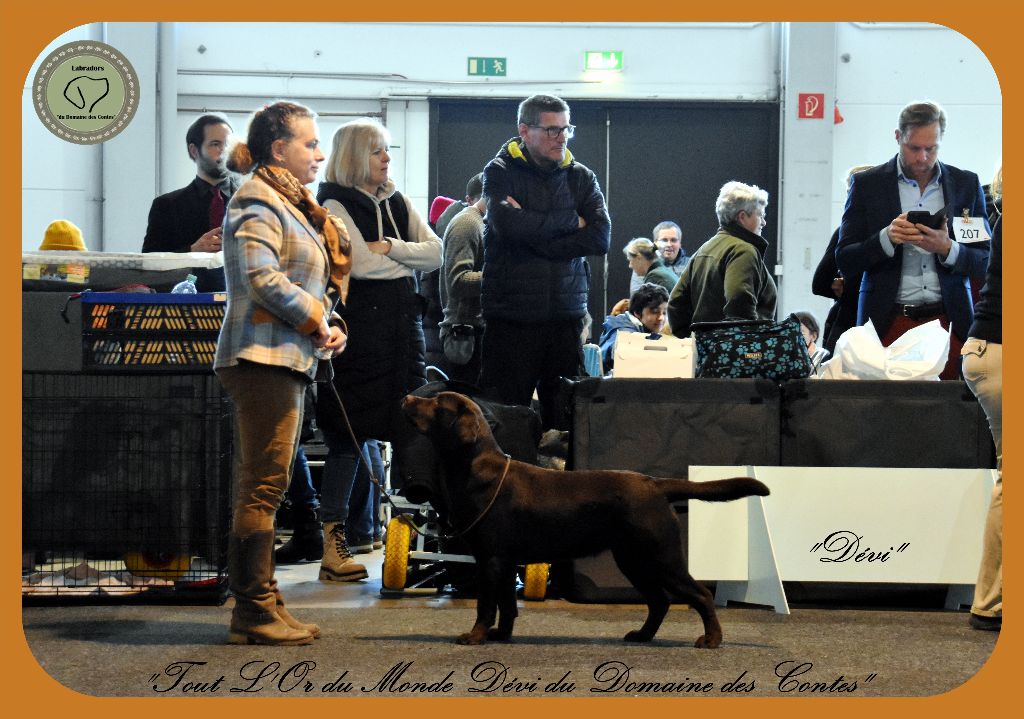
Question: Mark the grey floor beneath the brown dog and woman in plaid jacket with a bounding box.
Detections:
[24,551,997,697]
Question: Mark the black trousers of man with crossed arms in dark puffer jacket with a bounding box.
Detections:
[480,319,583,429]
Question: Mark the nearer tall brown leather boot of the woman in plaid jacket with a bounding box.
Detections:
[227,530,313,646]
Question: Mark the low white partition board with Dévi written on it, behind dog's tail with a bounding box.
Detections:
[688,467,995,585]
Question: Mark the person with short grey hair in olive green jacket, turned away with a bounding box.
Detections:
[669,181,776,337]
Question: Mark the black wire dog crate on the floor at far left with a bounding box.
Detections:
[22,373,231,602]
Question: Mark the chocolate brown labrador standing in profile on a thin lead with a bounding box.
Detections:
[403,392,768,648]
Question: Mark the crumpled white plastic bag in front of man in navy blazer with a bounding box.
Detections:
[818,320,949,381]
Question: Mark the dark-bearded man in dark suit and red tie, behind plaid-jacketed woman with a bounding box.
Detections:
[142,115,239,292]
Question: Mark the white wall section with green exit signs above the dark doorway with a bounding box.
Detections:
[172,23,777,99]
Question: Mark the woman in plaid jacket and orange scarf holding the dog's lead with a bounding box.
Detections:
[214,102,348,645]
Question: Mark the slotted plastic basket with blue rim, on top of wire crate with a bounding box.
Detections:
[82,292,225,374]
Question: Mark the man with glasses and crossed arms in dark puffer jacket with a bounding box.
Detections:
[480,95,611,429]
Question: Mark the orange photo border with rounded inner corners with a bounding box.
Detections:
[0,0,1011,719]
